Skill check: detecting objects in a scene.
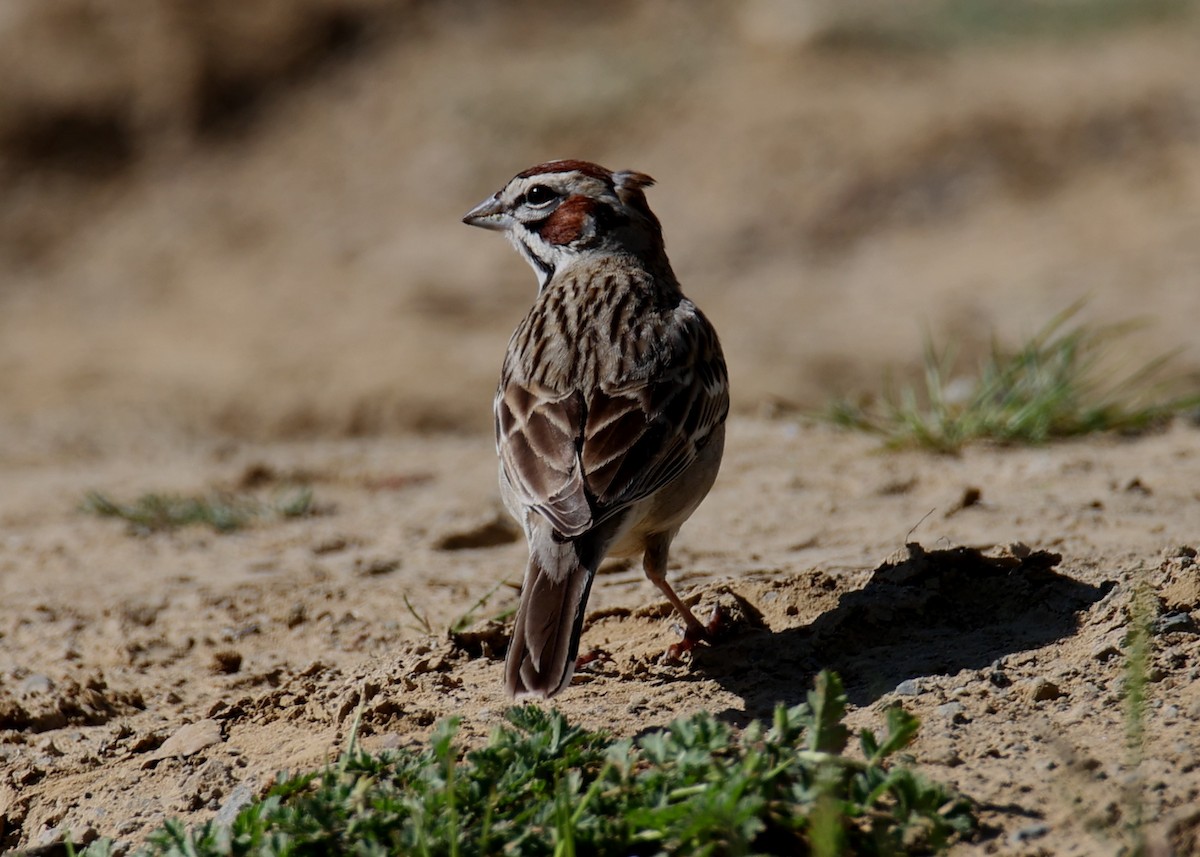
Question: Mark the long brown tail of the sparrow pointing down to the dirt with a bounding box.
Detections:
[504,543,593,699]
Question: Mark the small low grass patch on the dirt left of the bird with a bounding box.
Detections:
[80,487,313,533]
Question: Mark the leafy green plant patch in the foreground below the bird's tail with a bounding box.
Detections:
[75,673,976,857]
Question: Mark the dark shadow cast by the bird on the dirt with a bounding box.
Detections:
[692,544,1114,720]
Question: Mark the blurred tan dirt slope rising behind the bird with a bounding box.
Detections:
[0,0,1200,463]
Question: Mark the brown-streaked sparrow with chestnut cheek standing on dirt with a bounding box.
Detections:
[463,160,730,699]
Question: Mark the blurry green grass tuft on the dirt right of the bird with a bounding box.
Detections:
[826,305,1200,453]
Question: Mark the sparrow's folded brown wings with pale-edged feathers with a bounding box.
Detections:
[496,301,730,538]
